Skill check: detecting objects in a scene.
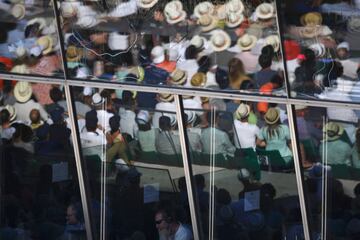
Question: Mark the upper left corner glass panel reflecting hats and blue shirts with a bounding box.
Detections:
[0,0,64,77]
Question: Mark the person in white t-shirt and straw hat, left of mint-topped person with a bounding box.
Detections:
[234,103,260,149]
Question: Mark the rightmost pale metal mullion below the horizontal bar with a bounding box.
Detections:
[286,104,311,240]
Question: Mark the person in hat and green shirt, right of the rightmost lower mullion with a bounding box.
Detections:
[319,122,351,166]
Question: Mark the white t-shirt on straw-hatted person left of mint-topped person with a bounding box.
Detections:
[234,120,260,149]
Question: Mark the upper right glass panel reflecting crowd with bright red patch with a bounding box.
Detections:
[281,0,360,102]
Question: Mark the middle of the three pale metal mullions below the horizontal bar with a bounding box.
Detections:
[175,95,203,240]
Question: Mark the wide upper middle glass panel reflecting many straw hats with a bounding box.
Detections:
[60,0,286,96]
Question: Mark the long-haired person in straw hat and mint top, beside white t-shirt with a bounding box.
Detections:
[257,108,292,164]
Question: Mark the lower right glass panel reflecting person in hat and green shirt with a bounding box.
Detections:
[295,105,360,239]
